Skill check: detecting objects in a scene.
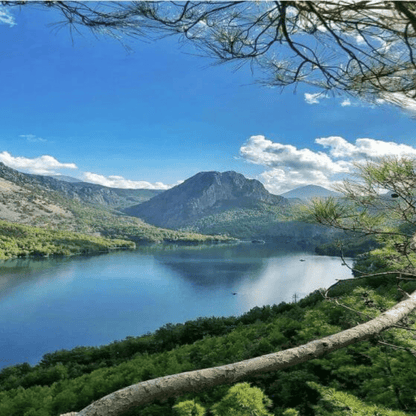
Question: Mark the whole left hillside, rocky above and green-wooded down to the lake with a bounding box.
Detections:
[0,163,233,259]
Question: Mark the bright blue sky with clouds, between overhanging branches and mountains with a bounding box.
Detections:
[0,6,416,193]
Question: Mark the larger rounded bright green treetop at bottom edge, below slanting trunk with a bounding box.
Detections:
[212,383,272,416]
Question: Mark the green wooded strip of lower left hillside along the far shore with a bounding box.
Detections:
[0,209,233,259]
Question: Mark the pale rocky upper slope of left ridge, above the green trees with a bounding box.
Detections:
[0,163,160,228]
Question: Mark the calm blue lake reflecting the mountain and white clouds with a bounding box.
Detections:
[0,244,351,368]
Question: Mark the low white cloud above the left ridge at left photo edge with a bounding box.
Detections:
[0,152,78,175]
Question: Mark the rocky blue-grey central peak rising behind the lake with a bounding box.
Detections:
[124,171,288,228]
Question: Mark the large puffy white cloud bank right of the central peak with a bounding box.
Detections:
[240,135,416,194]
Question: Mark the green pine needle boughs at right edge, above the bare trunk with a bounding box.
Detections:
[310,157,416,273]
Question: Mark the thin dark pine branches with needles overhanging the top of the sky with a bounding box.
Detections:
[2,0,416,107]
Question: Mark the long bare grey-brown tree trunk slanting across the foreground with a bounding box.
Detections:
[62,291,416,416]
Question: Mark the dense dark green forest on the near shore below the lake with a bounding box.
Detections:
[0,249,416,416]
